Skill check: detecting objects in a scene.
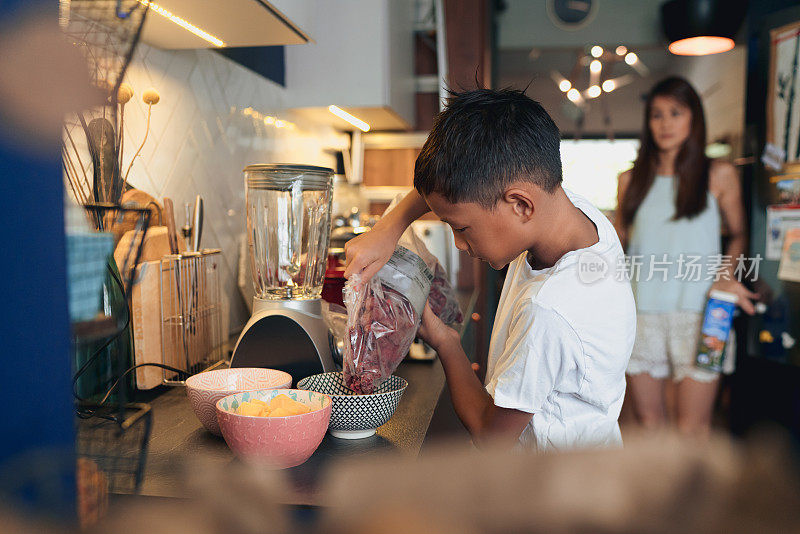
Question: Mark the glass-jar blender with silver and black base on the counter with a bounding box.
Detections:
[231,164,336,381]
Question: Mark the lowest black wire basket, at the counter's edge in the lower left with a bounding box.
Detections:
[76,403,152,493]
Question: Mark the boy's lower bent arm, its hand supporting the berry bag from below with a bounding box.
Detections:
[419,304,533,447]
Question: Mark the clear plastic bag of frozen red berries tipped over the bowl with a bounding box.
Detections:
[342,246,433,394]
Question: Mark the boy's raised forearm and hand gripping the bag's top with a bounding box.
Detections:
[344,189,430,280]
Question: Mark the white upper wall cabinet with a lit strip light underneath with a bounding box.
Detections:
[286,0,415,130]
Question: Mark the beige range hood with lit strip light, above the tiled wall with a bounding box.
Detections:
[140,0,311,50]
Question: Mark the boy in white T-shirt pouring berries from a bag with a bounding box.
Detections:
[345,89,636,450]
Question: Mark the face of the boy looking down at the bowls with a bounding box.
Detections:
[425,193,525,269]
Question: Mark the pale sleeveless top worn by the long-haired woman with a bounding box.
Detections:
[628,176,721,313]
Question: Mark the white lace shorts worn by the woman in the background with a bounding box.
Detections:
[627,312,736,382]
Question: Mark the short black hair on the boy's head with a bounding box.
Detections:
[414,89,562,209]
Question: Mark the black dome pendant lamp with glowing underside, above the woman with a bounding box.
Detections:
[661,0,747,56]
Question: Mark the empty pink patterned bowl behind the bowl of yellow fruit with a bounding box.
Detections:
[186,367,292,436]
